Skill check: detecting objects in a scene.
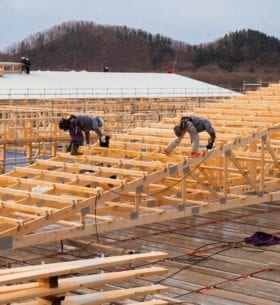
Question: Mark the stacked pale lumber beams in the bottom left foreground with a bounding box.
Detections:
[0,252,167,305]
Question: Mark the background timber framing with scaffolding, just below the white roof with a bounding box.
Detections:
[0,97,212,173]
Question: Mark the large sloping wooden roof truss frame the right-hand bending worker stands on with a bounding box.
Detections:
[0,85,280,250]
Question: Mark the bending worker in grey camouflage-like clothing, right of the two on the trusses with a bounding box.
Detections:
[164,115,216,158]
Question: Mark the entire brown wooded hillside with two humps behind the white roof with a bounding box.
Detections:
[0,21,280,88]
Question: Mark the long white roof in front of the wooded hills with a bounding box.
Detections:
[0,71,238,99]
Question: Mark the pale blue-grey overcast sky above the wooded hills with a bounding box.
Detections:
[0,0,280,50]
